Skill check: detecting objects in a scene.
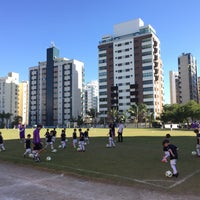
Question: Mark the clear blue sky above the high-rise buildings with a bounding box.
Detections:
[0,0,200,103]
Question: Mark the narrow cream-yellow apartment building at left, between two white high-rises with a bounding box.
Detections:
[18,81,29,124]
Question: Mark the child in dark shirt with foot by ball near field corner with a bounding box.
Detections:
[163,139,179,177]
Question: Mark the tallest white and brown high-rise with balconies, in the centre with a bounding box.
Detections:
[98,19,164,120]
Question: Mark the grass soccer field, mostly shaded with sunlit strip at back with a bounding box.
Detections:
[0,128,200,194]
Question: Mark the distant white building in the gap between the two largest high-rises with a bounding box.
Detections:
[85,80,99,112]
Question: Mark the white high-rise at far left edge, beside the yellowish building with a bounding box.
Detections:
[0,72,19,125]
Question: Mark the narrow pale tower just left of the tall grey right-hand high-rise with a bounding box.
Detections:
[169,71,179,104]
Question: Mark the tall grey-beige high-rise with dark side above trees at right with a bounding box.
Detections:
[178,53,198,104]
